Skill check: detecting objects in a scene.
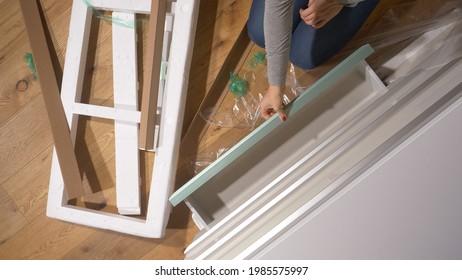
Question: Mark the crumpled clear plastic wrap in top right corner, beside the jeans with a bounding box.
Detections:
[368,0,462,85]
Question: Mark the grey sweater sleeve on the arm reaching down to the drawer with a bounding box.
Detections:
[263,0,294,86]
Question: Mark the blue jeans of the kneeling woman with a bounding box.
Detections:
[247,0,379,70]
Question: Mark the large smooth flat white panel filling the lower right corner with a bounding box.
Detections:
[255,85,462,260]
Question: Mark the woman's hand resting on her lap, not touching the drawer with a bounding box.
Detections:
[300,0,343,29]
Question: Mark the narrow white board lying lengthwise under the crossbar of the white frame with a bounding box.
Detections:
[112,12,141,215]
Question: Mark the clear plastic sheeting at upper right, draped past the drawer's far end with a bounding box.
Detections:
[358,0,462,85]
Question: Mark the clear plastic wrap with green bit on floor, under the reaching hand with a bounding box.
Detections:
[188,50,306,176]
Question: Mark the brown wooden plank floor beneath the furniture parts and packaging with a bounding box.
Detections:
[0,0,454,259]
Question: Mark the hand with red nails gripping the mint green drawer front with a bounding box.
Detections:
[260,85,287,121]
